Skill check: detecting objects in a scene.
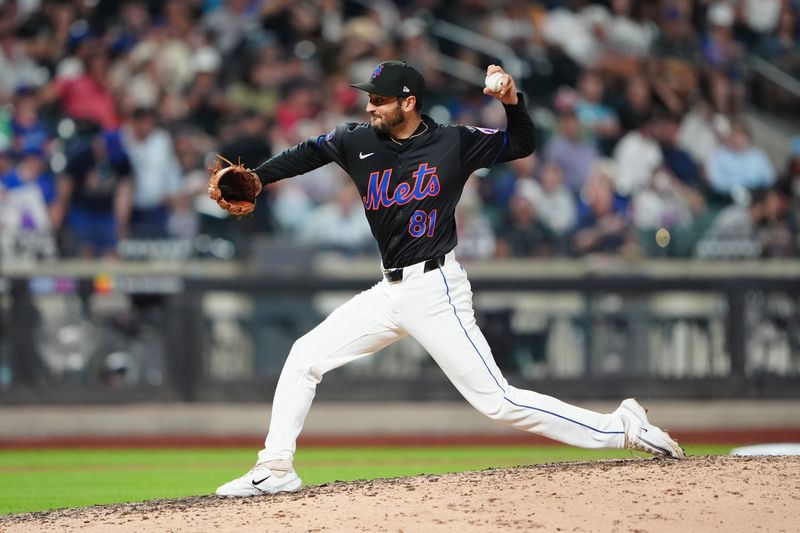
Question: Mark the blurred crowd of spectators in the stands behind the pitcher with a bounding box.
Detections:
[0,0,800,259]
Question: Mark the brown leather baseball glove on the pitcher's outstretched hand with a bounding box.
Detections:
[208,156,262,217]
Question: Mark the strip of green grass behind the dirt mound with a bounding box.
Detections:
[0,446,731,514]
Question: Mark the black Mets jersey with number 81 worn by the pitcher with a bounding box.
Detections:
[255,95,536,268]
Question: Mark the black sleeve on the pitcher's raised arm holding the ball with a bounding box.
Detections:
[459,94,536,172]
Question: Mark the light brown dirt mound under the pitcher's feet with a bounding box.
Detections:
[0,457,800,533]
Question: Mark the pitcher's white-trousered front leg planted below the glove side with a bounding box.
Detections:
[258,284,406,462]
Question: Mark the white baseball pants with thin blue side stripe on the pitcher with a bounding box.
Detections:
[259,252,625,462]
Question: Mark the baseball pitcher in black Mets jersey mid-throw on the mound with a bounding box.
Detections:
[209,61,684,496]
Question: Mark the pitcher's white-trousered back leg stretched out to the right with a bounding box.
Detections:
[400,263,625,449]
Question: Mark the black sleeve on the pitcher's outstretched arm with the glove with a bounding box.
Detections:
[255,124,352,185]
